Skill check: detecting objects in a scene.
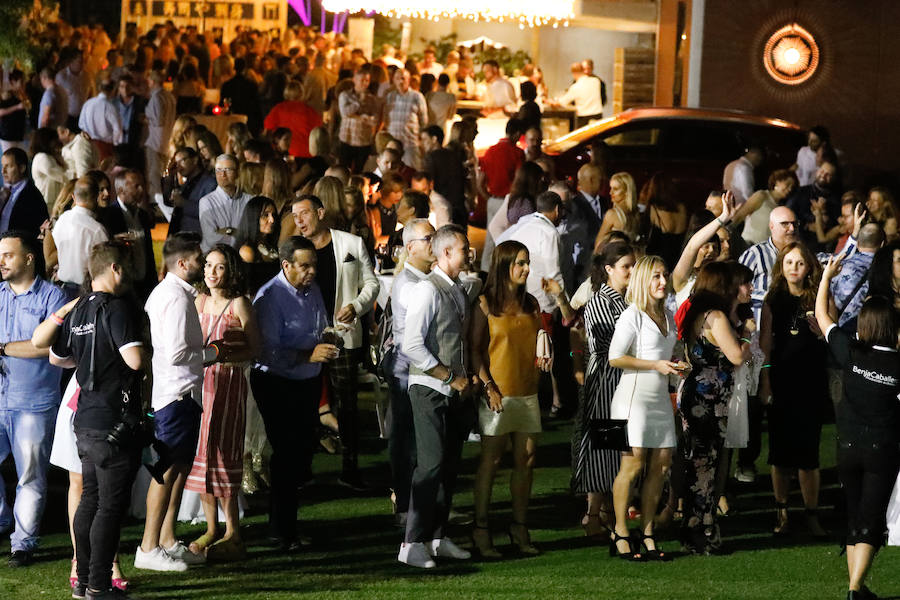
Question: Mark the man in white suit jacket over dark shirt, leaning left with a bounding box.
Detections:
[291,195,378,491]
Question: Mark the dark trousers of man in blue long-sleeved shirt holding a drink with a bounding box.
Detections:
[250,369,322,542]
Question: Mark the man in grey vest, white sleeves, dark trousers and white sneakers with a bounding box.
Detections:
[397,225,471,569]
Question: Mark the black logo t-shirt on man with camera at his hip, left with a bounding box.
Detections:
[51,292,142,431]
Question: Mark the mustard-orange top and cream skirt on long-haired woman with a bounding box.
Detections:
[478,314,541,435]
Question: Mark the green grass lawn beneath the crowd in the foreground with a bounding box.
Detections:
[0,406,900,600]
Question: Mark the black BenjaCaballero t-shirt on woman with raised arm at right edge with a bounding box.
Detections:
[827,327,900,446]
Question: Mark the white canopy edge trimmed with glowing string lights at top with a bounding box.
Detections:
[322,0,575,29]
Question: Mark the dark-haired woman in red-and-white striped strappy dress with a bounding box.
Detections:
[184,244,259,560]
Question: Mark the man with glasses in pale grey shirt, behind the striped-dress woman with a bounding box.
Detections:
[200,154,250,252]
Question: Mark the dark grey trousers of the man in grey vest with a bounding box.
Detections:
[405,385,469,542]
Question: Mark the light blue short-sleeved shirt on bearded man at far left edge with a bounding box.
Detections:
[0,277,66,412]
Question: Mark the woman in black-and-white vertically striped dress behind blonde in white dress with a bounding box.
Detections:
[573,242,635,541]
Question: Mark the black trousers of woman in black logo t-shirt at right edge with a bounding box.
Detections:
[838,442,900,548]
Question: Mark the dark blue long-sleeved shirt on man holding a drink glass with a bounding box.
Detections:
[253,271,328,379]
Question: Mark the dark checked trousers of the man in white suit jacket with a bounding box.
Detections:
[326,348,362,478]
